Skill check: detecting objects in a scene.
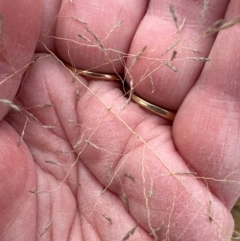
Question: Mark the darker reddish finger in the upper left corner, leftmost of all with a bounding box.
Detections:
[0,0,41,120]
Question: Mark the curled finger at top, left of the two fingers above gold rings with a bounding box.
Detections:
[56,0,147,72]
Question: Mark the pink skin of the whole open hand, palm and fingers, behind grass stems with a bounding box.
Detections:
[0,0,240,241]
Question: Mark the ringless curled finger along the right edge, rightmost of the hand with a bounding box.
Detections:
[174,1,240,209]
